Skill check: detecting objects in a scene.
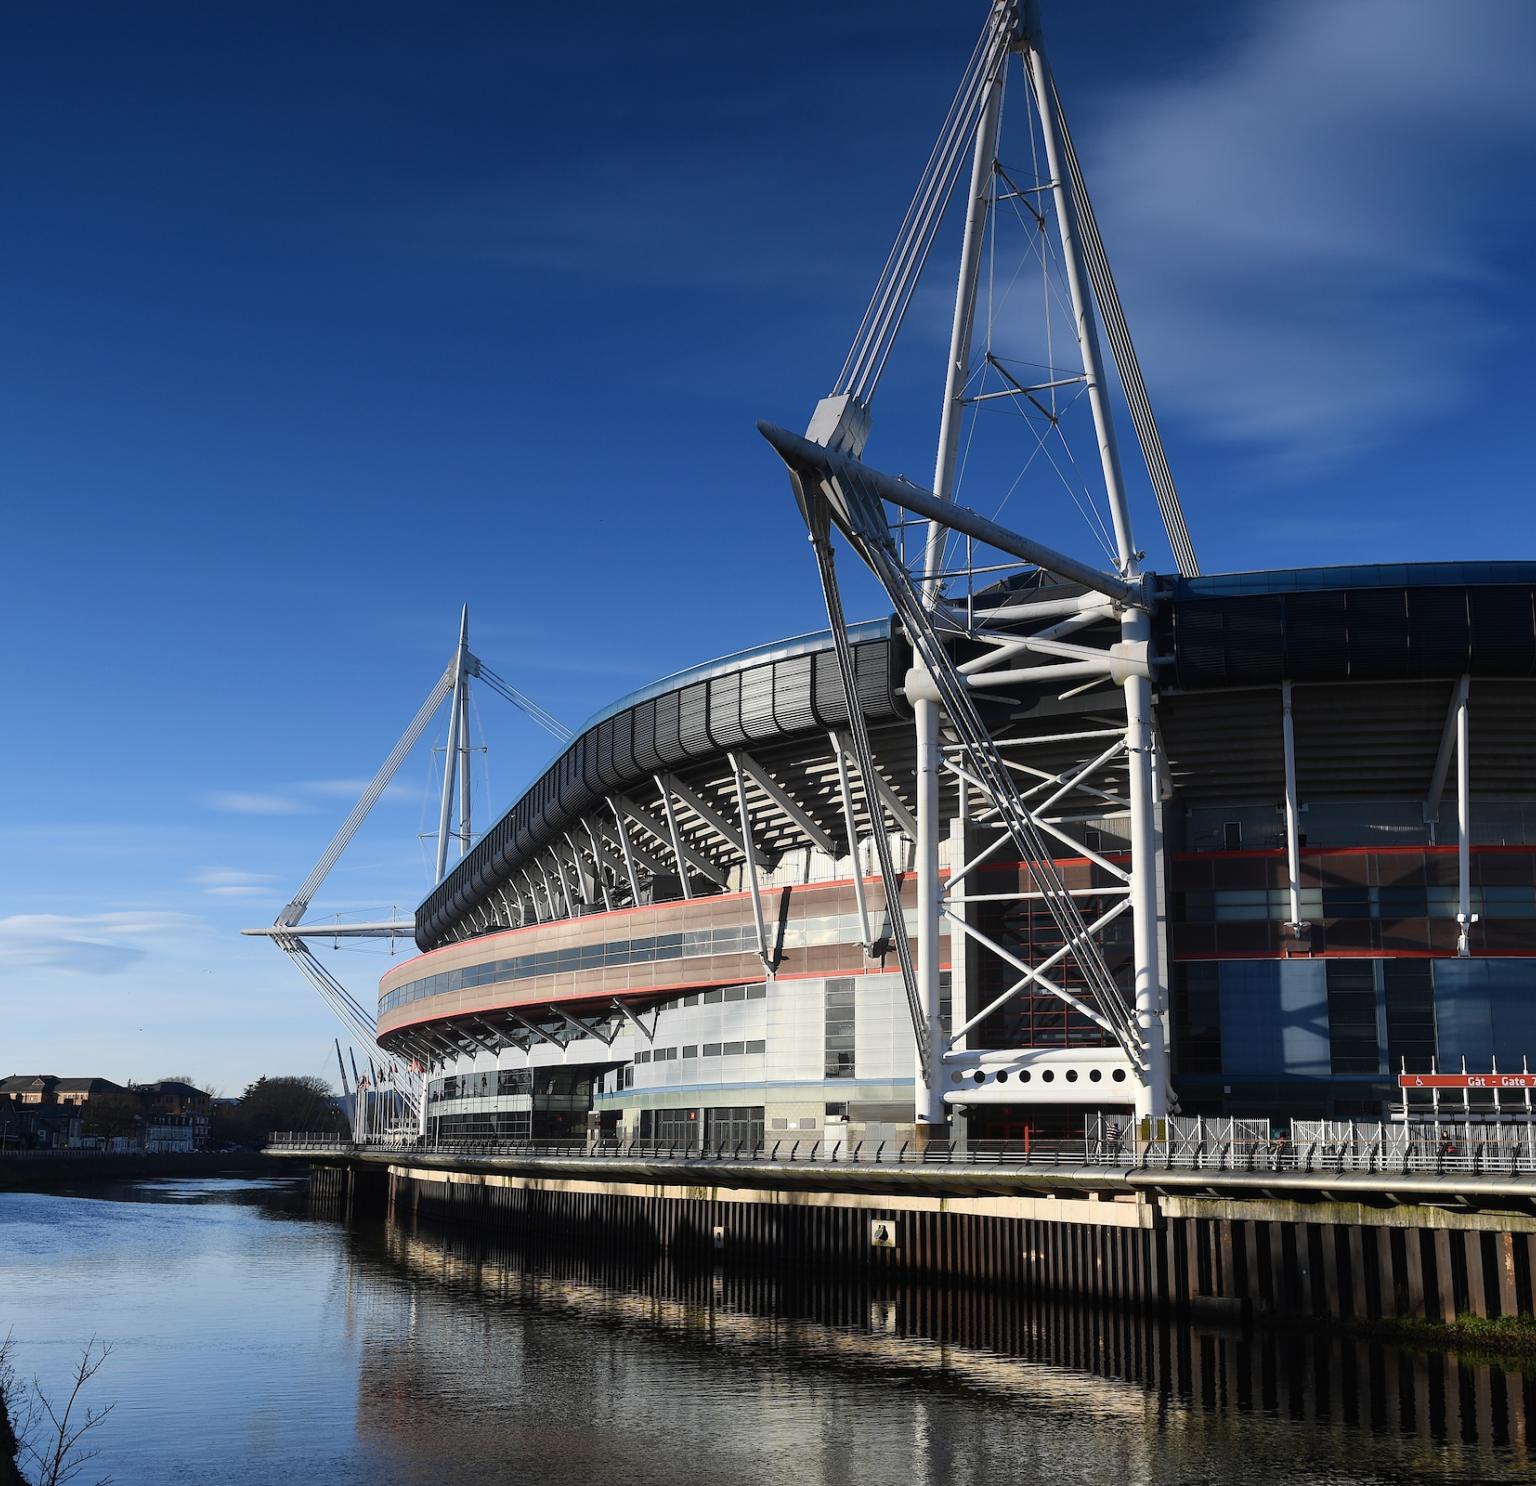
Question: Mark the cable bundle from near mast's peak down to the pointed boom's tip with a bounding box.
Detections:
[834,5,1014,403]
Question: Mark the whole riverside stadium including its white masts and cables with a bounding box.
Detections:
[251,0,1536,1149]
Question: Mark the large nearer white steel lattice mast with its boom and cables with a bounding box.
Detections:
[759,0,1179,1126]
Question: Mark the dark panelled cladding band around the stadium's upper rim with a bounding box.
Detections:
[416,562,1536,950]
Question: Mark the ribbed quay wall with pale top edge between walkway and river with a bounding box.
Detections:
[302,1153,1536,1323]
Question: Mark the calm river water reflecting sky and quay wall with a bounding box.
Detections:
[0,1180,1536,1486]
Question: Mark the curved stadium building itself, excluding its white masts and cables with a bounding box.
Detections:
[378,562,1536,1148]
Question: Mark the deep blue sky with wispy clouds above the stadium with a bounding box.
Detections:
[0,0,1536,1091]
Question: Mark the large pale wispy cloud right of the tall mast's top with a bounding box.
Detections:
[1086,0,1536,458]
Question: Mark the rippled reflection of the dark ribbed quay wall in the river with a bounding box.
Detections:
[364,1222,1536,1481]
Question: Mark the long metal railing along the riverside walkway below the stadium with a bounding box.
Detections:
[269,1123,1536,1176]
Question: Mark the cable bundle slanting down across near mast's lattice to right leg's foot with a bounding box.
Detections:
[823,461,1140,1060]
